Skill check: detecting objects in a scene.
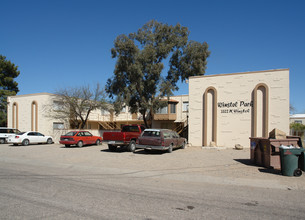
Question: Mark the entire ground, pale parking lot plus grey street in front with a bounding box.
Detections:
[0,144,305,220]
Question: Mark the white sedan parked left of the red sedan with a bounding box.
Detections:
[7,131,53,146]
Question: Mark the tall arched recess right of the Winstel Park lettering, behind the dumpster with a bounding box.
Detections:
[252,83,269,137]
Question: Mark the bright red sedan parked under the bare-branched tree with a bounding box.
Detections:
[59,131,102,147]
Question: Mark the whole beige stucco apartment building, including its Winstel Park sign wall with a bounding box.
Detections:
[7,69,289,148]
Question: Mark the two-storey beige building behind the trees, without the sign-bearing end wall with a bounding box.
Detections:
[7,93,188,142]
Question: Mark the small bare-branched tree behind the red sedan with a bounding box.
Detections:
[51,84,108,129]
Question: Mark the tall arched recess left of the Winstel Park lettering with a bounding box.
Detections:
[202,87,217,146]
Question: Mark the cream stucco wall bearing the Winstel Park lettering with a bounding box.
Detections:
[189,69,289,147]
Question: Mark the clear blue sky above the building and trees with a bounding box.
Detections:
[0,0,305,113]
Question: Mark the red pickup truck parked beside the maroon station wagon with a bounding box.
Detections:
[103,125,145,152]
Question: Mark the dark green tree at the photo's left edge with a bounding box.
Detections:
[0,55,20,127]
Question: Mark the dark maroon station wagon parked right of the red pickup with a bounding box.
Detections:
[136,129,186,153]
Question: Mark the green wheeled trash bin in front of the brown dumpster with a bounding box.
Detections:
[280,146,304,176]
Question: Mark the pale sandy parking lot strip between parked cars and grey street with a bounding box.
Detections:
[0,141,305,190]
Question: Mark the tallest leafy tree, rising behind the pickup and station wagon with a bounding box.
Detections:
[106,20,210,127]
